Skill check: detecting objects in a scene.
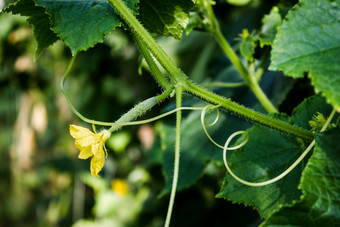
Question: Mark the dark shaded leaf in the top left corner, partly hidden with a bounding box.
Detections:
[0,0,58,60]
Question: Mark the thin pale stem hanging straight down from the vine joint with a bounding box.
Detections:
[164,85,183,227]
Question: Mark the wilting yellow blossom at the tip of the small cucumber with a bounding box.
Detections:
[70,125,111,177]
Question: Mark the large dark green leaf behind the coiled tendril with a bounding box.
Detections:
[217,97,330,217]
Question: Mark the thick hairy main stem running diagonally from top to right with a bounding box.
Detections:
[109,0,314,140]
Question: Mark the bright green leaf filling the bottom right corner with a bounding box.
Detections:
[262,127,340,227]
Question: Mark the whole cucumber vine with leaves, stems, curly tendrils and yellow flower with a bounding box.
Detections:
[1,0,340,227]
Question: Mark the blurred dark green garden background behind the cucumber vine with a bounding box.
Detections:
[0,1,302,227]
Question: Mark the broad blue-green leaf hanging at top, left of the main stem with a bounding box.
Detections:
[36,0,138,55]
